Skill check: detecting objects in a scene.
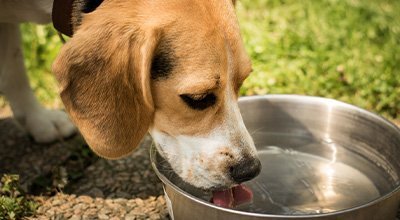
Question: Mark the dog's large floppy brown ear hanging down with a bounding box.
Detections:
[53,22,159,159]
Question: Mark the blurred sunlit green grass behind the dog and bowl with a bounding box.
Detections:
[3,0,400,118]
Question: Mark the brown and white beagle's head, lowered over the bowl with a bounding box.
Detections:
[53,0,260,189]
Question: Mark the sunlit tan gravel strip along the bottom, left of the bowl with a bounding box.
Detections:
[32,193,168,220]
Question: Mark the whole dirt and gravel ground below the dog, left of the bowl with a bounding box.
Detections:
[0,118,169,220]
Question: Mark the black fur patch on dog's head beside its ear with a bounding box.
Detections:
[151,42,176,80]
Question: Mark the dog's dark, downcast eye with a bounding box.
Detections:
[180,93,217,110]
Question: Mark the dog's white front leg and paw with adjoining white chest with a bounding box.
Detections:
[0,0,76,142]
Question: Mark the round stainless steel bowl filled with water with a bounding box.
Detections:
[151,95,400,220]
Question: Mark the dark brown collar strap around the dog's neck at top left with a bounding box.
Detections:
[52,0,74,37]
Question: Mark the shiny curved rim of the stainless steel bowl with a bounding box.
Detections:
[150,94,400,219]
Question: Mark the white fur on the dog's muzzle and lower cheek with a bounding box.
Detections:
[150,120,256,189]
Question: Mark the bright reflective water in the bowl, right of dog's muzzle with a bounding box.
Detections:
[237,146,380,214]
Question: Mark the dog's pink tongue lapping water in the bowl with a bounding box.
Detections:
[212,185,253,208]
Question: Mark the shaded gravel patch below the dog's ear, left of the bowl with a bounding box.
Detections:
[68,136,163,199]
